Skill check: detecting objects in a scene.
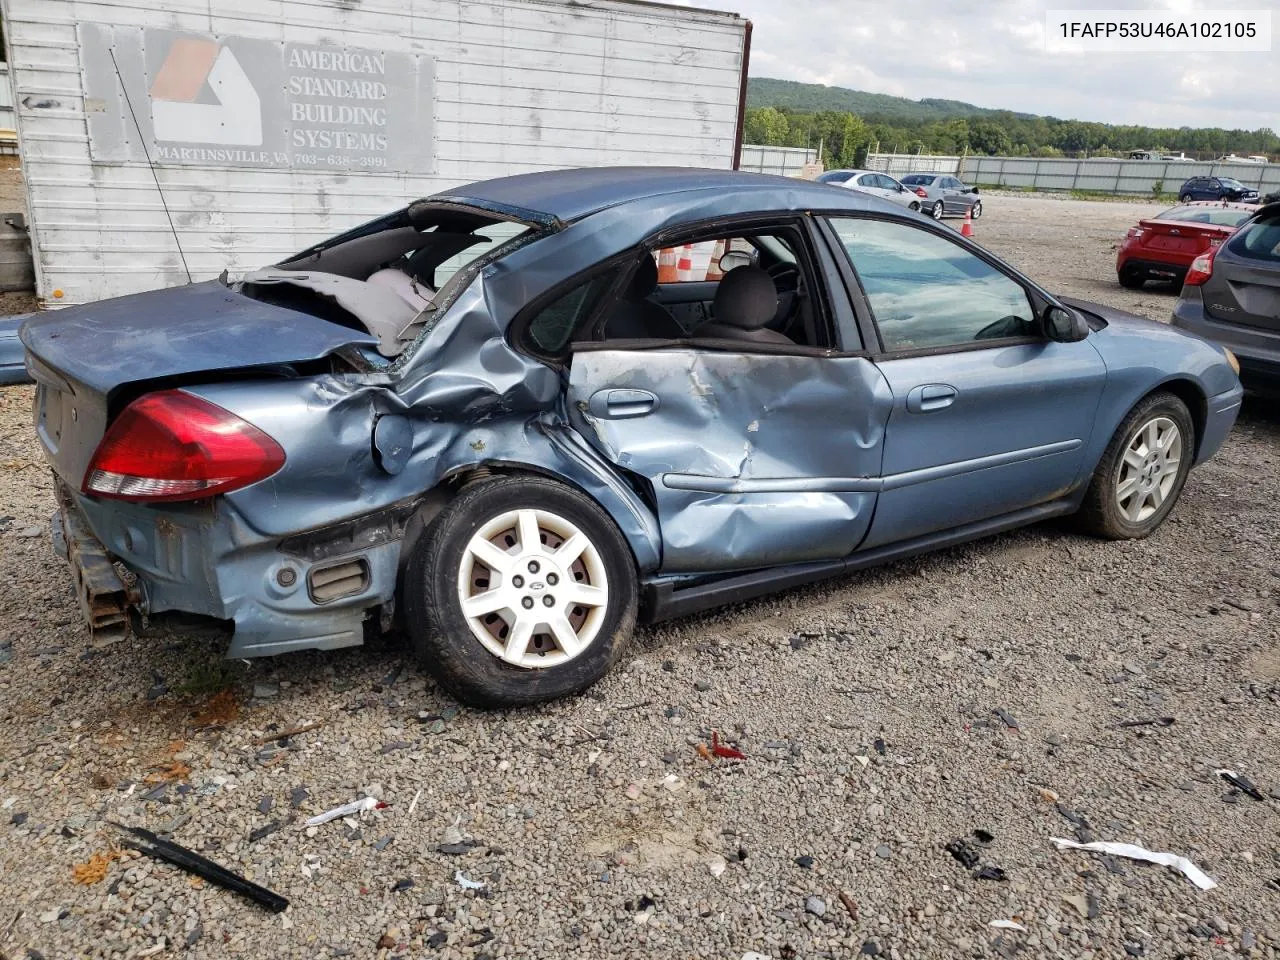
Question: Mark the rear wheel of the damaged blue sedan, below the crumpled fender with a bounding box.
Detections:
[403,476,637,707]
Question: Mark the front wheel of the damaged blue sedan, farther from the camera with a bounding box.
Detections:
[1076,392,1196,540]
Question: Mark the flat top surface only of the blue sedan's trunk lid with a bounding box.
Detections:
[20,280,378,394]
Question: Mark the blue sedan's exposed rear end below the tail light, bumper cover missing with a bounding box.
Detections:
[54,483,401,657]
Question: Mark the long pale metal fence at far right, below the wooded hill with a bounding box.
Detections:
[960,156,1280,195]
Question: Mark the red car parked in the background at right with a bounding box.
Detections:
[1116,200,1258,289]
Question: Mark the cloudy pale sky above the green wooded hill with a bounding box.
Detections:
[682,0,1280,131]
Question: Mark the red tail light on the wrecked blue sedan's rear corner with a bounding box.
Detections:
[83,390,284,502]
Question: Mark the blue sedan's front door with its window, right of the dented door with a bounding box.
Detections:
[829,218,1106,548]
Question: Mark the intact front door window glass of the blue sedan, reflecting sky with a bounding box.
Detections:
[831,218,1038,351]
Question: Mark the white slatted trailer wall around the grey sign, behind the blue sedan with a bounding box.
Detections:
[4,0,745,305]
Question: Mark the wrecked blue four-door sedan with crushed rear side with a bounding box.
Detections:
[22,168,1240,704]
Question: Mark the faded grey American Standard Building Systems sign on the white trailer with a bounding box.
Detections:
[77,23,435,174]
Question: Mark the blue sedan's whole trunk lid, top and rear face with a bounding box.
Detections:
[20,280,378,489]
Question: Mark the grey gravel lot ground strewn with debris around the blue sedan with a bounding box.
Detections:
[0,195,1280,960]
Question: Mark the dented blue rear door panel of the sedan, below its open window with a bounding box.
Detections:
[568,344,892,573]
